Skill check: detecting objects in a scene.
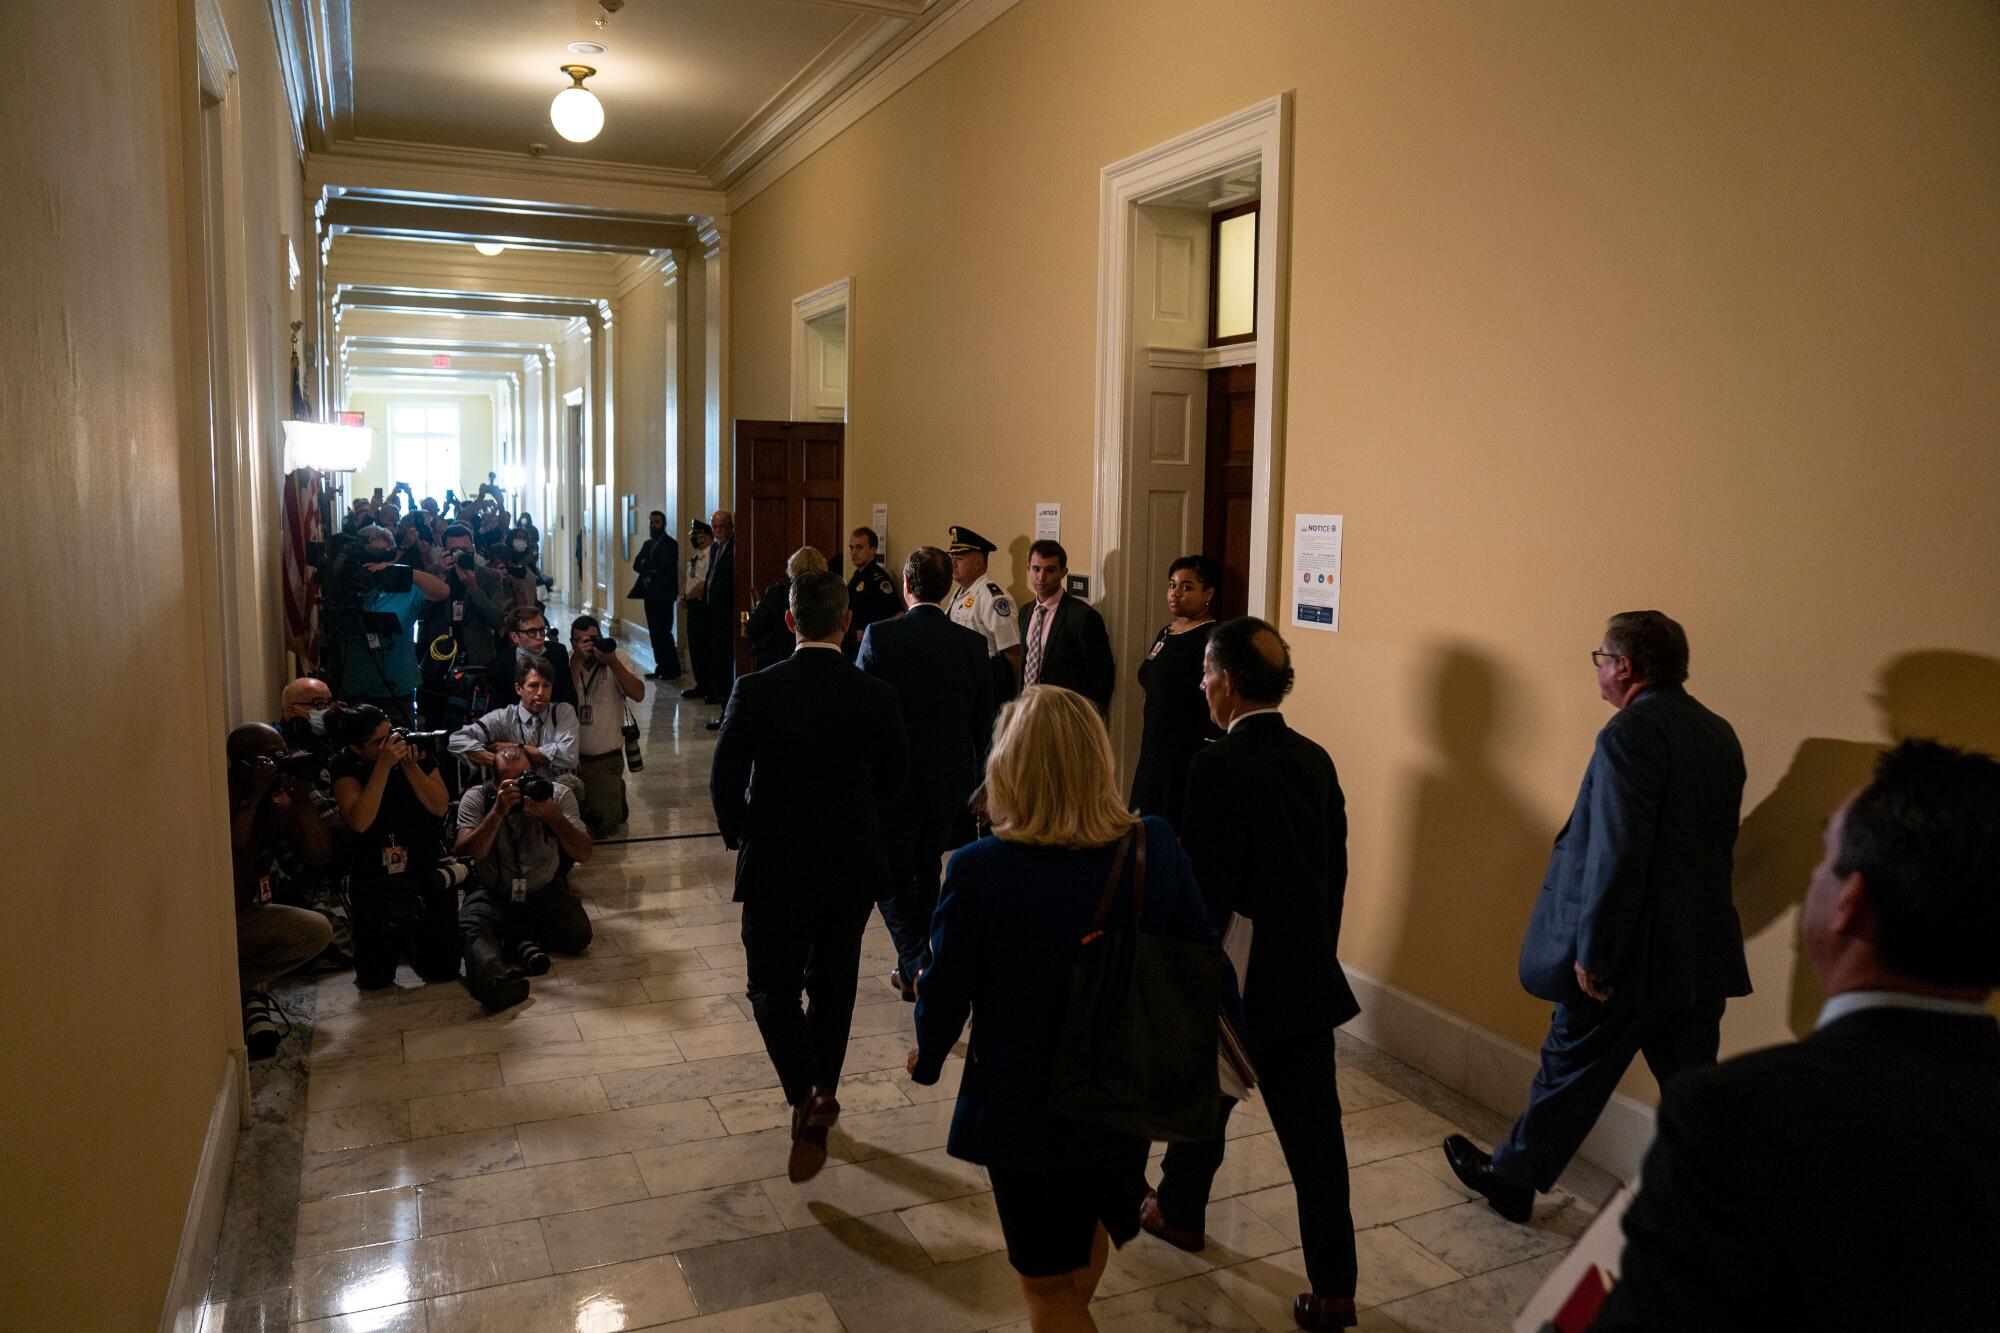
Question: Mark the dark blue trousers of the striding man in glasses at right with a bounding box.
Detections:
[1494,993,1724,1191]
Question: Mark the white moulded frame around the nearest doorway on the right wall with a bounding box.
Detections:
[1090,92,1292,757]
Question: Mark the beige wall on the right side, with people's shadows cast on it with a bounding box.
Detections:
[730,0,2000,1072]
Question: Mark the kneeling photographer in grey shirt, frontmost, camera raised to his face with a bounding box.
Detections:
[456,743,590,1011]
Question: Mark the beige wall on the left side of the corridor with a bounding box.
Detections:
[0,0,300,1329]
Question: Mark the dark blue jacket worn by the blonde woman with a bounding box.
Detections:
[912,819,1234,1171]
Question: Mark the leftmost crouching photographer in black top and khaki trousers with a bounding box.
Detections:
[226,723,334,1061]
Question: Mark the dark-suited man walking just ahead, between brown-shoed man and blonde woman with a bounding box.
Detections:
[850,546,994,1001]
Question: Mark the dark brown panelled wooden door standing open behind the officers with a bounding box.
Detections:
[736,420,846,671]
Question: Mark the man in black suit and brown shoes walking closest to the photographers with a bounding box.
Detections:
[708,568,908,1181]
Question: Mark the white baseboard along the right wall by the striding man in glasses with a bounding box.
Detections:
[1342,963,1654,1181]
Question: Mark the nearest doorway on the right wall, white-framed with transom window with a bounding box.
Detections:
[1092,94,1290,773]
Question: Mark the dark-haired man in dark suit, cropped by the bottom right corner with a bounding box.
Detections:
[1592,741,2000,1331]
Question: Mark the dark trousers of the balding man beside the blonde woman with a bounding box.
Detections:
[1160,1029,1356,1299]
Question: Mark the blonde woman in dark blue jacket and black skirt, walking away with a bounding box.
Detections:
[910,685,1216,1333]
